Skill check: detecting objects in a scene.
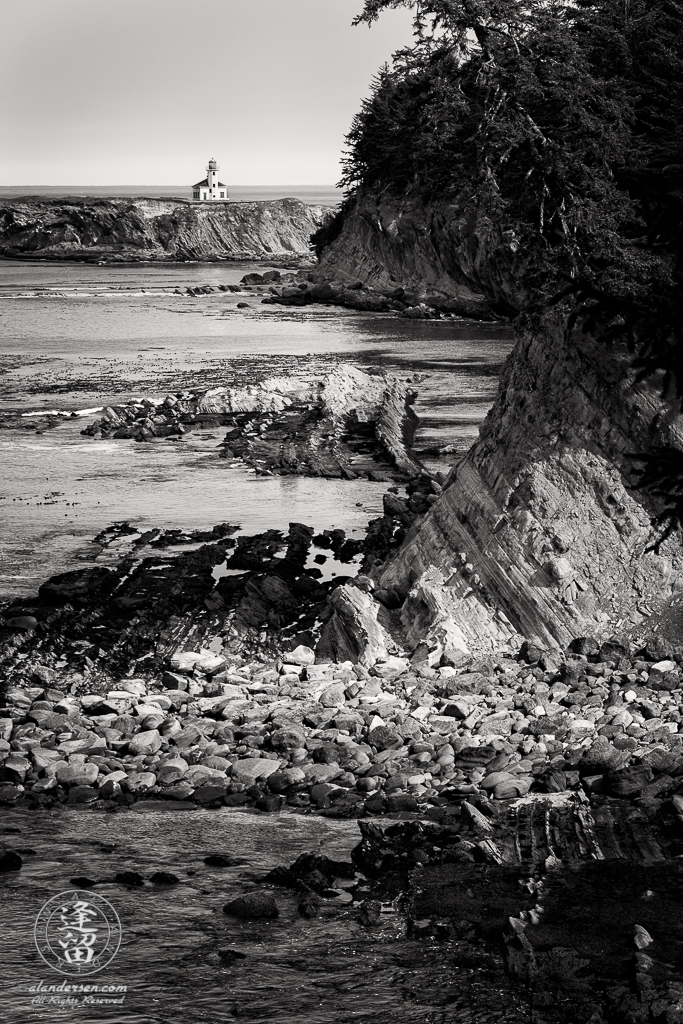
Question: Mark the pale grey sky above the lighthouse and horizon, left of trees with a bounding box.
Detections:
[0,0,411,185]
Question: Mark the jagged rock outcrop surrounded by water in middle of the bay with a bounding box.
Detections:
[82,364,422,480]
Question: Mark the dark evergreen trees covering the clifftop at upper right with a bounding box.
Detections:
[342,0,683,532]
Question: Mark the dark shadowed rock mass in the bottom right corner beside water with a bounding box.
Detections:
[339,806,683,1024]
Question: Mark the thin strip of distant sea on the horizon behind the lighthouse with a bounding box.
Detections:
[0,182,344,206]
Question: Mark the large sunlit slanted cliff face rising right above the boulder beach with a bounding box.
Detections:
[382,315,683,646]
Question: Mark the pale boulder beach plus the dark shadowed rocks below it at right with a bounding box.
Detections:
[0,598,683,1024]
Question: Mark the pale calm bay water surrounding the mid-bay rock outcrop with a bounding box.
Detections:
[0,261,511,597]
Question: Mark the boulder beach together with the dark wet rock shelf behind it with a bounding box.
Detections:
[0,477,683,827]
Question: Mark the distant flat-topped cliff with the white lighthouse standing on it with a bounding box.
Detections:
[0,198,329,262]
